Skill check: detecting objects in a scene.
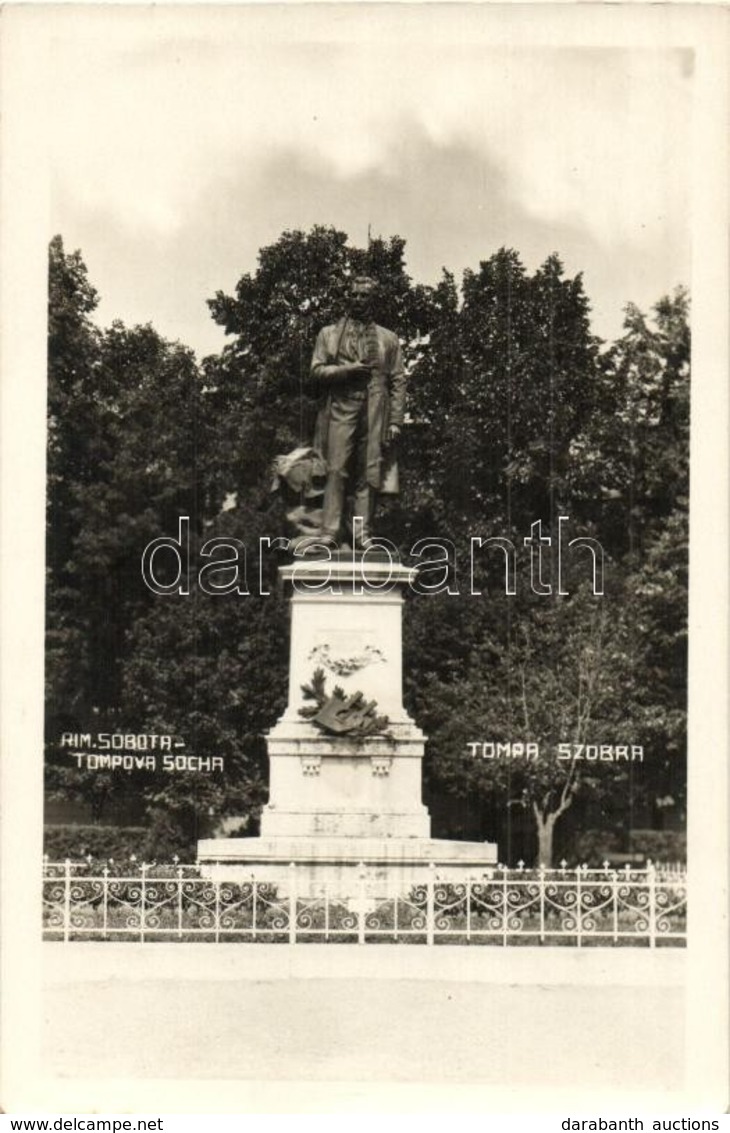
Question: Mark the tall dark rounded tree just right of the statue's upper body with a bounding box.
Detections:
[414,249,597,534]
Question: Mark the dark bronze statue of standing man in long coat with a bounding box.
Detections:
[311,275,406,550]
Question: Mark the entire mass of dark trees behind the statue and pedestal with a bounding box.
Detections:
[46,228,689,861]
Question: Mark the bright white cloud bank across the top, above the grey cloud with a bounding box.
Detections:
[49,33,689,242]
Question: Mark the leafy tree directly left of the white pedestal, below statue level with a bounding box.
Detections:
[122,566,288,853]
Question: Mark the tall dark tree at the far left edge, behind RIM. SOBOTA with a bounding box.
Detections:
[46,245,208,833]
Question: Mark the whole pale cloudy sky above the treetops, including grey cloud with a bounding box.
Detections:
[48,5,693,355]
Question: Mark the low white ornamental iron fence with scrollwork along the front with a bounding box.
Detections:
[43,861,687,948]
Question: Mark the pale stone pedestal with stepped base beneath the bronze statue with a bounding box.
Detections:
[198,554,496,896]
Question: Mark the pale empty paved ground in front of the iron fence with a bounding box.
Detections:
[44,944,684,1092]
